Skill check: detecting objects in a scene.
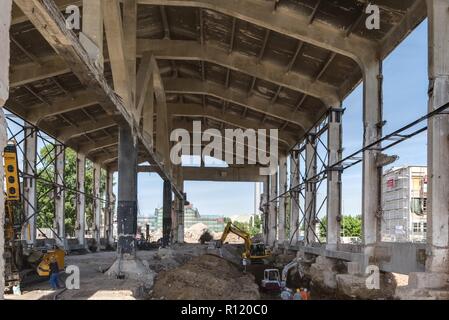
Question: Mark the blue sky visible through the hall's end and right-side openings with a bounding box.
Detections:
[135,22,428,216]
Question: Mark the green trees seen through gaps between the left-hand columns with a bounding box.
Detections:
[36,146,101,236]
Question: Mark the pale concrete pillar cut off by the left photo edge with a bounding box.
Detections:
[0,0,12,300]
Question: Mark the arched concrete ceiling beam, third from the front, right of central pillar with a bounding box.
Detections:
[165,79,312,131]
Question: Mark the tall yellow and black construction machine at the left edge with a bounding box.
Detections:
[3,142,65,291]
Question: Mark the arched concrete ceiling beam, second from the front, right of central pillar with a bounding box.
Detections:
[138,40,339,104]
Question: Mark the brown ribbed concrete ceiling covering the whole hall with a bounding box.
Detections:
[7,0,426,170]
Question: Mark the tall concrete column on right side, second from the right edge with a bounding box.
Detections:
[362,61,382,249]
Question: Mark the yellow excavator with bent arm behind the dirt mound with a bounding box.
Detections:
[217,221,271,263]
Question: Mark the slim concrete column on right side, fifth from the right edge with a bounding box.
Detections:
[288,151,300,245]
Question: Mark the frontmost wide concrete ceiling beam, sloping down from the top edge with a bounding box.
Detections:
[139,0,376,64]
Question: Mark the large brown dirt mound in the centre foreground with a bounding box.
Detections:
[153,255,260,300]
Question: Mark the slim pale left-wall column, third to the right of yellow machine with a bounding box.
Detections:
[75,153,86,246]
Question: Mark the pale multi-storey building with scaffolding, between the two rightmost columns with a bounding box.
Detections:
[382,167,427,242]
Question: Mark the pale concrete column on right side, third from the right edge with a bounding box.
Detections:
[326,109,342,250]
